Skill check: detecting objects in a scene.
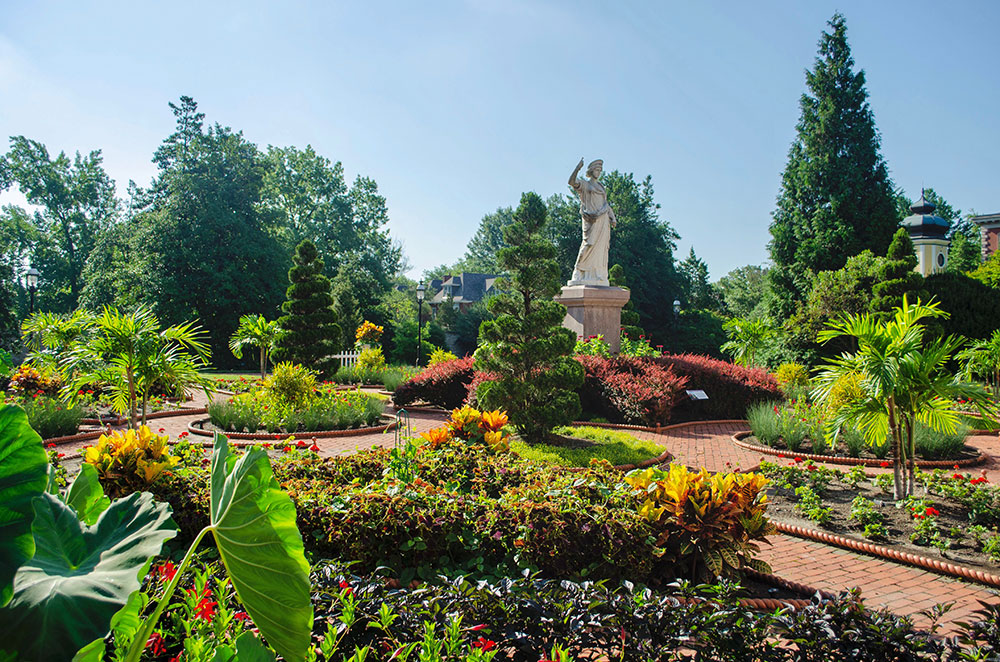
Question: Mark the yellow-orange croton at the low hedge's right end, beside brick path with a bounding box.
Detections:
[625,464,775,580]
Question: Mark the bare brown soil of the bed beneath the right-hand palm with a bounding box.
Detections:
[767,480,1000,574]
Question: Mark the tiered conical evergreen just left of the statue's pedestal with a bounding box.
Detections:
[475,193,583,443]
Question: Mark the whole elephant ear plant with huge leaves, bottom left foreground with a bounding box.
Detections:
[0,407,312,662]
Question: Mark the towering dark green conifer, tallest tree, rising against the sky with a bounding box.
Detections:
[769,13,898,319]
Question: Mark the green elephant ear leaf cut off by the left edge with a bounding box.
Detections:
[0,405,49,606]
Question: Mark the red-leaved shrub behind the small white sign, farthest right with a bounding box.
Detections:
[653,354,782,423]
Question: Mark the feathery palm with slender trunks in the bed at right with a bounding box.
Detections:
[813,295,996,499]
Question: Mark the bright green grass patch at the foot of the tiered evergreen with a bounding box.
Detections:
[511,426,664,467]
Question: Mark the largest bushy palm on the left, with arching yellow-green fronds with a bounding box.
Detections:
[62,306,209,428]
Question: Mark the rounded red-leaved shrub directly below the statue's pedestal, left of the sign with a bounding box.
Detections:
[576,356,687,425]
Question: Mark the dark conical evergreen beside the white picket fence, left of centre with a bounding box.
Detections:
[271,239,340,376]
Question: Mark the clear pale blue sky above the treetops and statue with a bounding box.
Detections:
[0,0,1000,279]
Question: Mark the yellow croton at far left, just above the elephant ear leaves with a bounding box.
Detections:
[83,425,177,497]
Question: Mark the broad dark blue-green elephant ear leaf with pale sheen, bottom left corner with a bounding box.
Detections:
[0,492,177,662]
